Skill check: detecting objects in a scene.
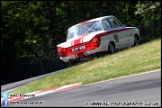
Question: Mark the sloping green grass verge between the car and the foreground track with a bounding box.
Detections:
[10,38,161,94]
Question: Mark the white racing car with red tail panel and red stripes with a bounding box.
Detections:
[57,15,140,64]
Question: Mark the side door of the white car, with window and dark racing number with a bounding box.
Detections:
[108,17,129,48]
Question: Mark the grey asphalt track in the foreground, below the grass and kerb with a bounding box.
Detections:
[4,70,161,107]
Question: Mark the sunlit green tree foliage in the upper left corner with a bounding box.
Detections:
[1,1,46,57]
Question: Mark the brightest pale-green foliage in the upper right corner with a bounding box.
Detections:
[135,1,161,39]
